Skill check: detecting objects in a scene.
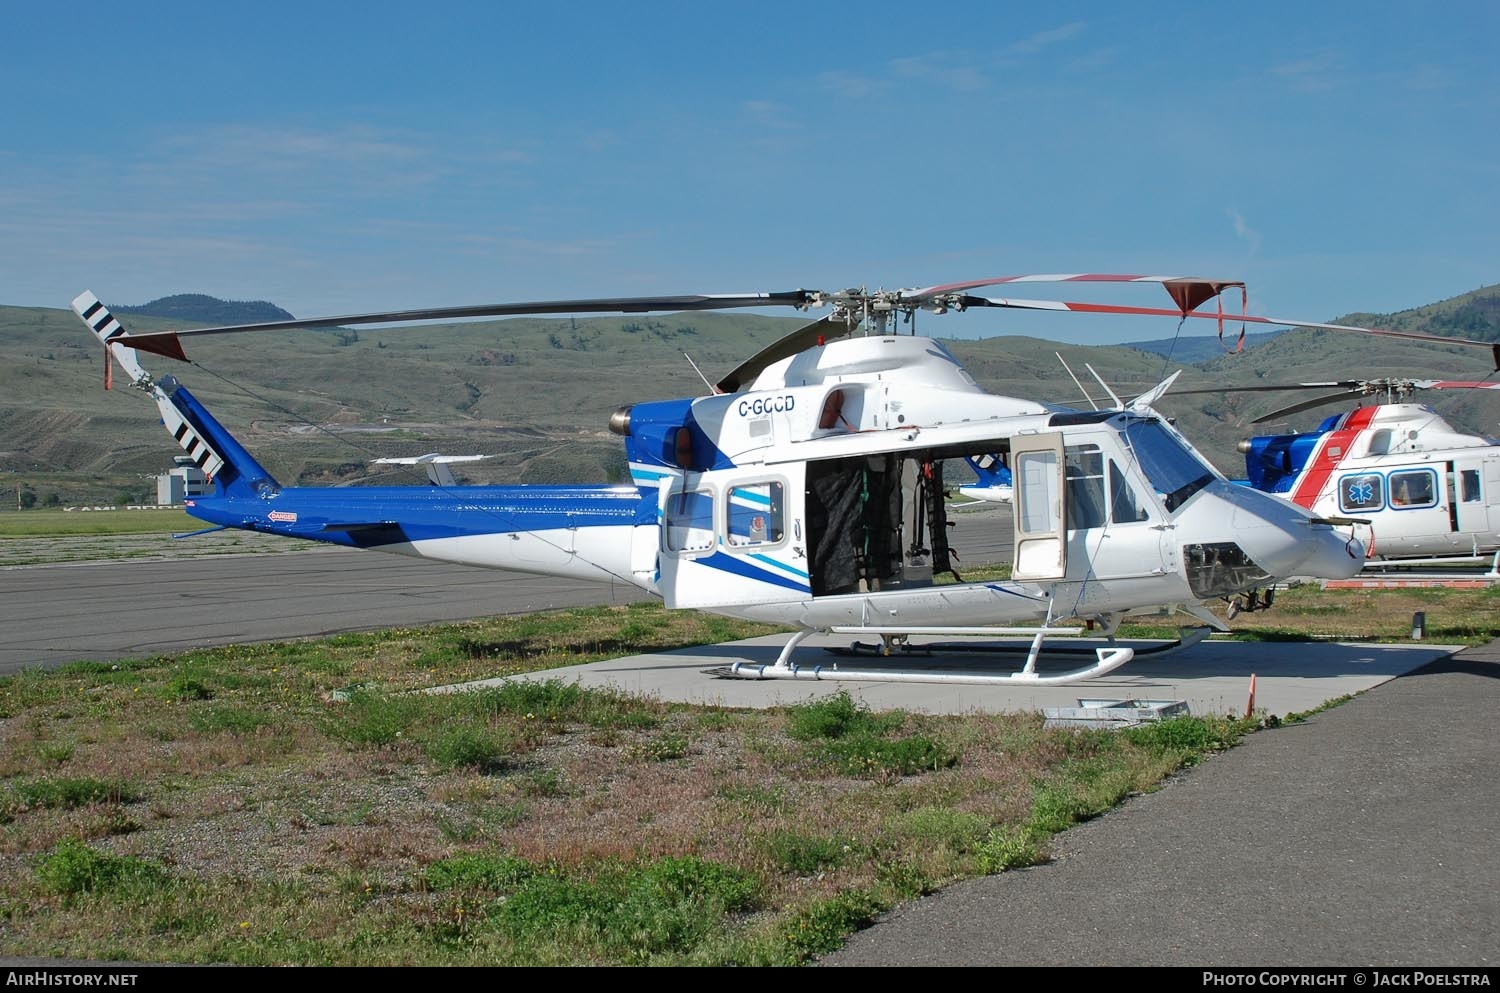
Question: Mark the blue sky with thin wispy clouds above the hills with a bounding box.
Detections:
[0,0,1500,344]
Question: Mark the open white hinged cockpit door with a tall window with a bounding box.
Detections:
[1011,434,1068,579]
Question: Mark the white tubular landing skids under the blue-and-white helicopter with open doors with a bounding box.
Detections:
[705,627,1209,686]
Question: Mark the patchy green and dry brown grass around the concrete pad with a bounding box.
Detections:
[0,587,1500,966]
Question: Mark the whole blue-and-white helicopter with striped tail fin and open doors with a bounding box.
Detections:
[72,275,1365,684]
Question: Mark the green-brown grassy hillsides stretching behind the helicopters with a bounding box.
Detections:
[0,287,1500,504]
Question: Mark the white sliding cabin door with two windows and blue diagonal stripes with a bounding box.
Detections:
[659,464,812,609]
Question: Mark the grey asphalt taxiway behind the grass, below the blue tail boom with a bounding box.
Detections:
[0,546,648,675]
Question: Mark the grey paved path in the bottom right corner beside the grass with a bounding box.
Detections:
[818,642,1500,968]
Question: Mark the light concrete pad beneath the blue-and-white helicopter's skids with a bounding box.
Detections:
[449,635,1463,717]
